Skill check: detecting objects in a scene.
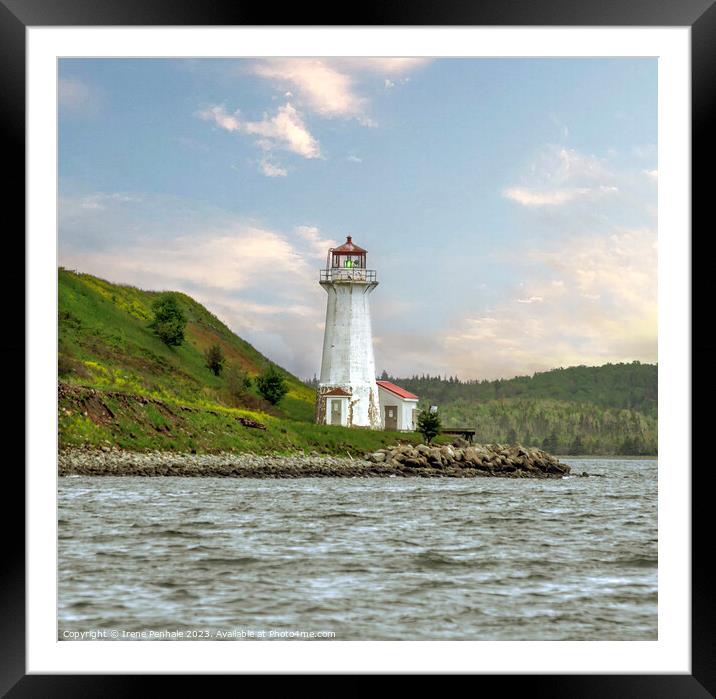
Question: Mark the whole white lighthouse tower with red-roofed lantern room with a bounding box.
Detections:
[316,236,381,429]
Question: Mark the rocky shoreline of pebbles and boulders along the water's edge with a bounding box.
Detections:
[58,440,570,478]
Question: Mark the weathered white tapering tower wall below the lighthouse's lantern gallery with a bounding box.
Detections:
[316,281,381,429]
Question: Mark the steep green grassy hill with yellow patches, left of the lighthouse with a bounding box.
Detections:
[58,268,417,454]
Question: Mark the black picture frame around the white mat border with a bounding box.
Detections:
[5,0,716,699]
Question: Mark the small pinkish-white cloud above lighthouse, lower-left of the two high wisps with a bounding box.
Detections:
[198,102,321,158]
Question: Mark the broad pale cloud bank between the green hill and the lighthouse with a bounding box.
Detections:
[59,193,336,377]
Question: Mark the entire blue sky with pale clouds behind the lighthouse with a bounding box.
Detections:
[58,58,658,379]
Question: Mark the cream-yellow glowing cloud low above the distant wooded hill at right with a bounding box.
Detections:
[437,229,657,378]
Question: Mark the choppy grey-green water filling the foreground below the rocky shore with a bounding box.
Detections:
[58,459,657,640]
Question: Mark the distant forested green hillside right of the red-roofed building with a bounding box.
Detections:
[383,362,658,454]
